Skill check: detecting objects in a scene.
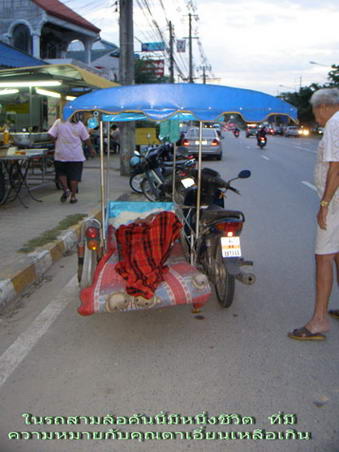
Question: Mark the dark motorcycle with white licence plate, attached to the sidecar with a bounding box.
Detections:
[183,168,256,308]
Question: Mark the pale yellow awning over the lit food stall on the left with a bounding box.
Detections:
[0,64,119,94]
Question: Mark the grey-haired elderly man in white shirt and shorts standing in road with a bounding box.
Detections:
[288,88,339,341]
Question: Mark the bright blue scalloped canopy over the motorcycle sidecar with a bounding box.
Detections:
[64,83,297,122]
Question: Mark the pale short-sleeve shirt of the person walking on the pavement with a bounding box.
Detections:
[48,119,89,162]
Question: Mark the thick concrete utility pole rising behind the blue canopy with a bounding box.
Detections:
[119,0,135,176]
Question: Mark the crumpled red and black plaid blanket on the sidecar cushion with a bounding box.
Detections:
[115,212,182,299]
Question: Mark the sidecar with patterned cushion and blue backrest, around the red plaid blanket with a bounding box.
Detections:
[78,201,211,315]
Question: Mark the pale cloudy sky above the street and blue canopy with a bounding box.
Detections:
[63,0,339,95]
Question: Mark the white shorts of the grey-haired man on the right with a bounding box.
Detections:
[315,208,339,254]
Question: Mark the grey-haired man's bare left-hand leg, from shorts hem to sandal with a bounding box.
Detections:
[305,254,336,333]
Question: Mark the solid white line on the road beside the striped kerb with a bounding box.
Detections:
[0,275,76,387]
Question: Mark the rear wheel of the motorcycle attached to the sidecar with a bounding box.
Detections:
[213,243,235,308]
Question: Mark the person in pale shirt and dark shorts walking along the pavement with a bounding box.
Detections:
[48,114,96,204]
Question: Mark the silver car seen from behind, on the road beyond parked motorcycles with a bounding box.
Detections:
[180,127,222,160]
